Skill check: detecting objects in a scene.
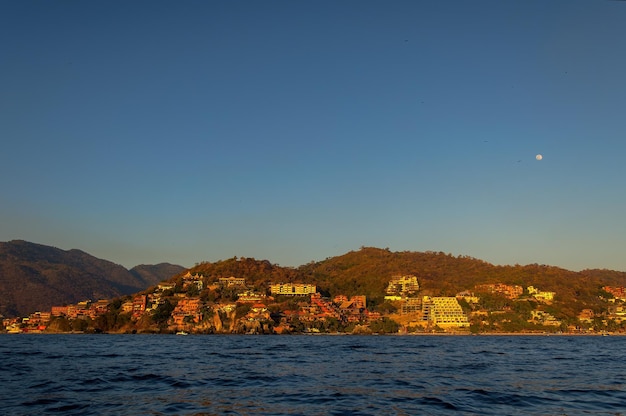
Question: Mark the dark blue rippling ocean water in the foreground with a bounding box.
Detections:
[0,334,626,416]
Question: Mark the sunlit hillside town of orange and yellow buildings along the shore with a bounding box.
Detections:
[2,271,626,334]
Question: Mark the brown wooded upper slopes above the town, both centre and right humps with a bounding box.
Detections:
[184,247,626,314]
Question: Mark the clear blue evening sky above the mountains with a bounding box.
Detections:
[0,0,626,271]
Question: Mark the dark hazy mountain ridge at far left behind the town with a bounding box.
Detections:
[0,240,185,316]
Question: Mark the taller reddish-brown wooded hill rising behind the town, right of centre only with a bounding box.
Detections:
[296,247,626,302]
